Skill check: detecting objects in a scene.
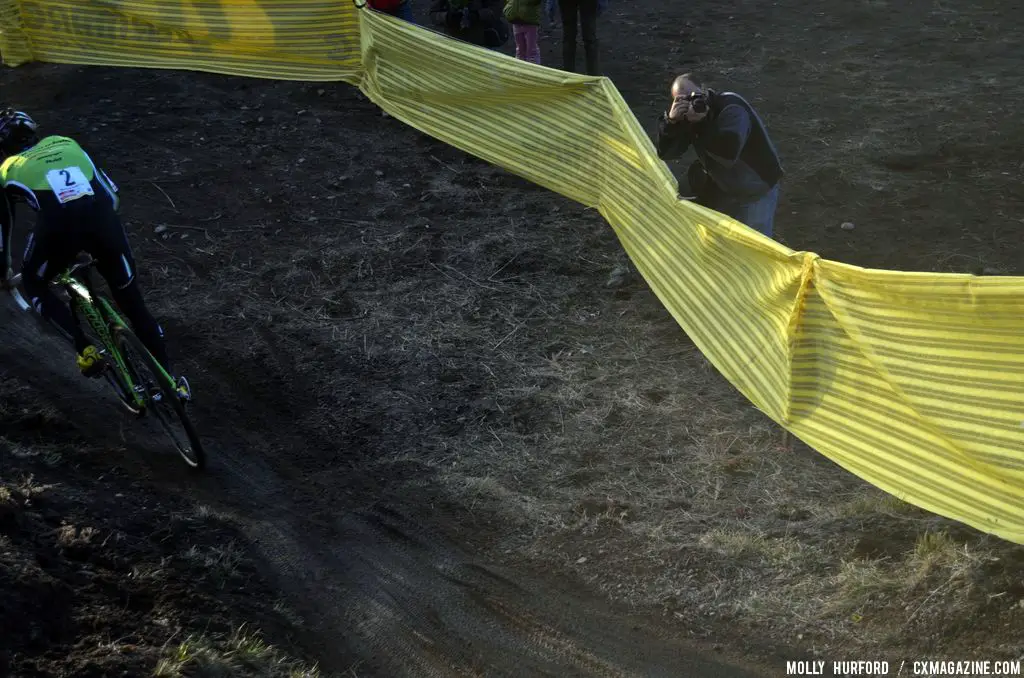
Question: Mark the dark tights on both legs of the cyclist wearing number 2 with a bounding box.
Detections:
[22,197,171,372]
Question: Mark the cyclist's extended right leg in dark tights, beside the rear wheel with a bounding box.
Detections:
[85,209,173,374]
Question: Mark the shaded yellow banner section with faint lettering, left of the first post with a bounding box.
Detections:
[0,0,361,83]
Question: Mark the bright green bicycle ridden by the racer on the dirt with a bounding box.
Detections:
[6,257,206,470]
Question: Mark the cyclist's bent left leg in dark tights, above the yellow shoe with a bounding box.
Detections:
[22,215,89,354]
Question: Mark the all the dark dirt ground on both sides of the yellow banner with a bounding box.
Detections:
[0,0,1024,676]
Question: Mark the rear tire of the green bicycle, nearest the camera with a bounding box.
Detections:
[113,327,206,471]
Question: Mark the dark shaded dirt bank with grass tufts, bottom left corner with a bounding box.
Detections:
[0,395,315,678]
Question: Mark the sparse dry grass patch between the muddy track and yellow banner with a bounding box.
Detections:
[165,144,1021,663]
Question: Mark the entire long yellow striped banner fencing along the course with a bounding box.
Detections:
[0,0,1024,544]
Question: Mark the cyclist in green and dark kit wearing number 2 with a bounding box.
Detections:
[0,109,191,399]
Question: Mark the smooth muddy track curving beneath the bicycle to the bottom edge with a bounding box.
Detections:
[0,297,763,678]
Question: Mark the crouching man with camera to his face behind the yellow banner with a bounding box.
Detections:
[656,74,783,238]
